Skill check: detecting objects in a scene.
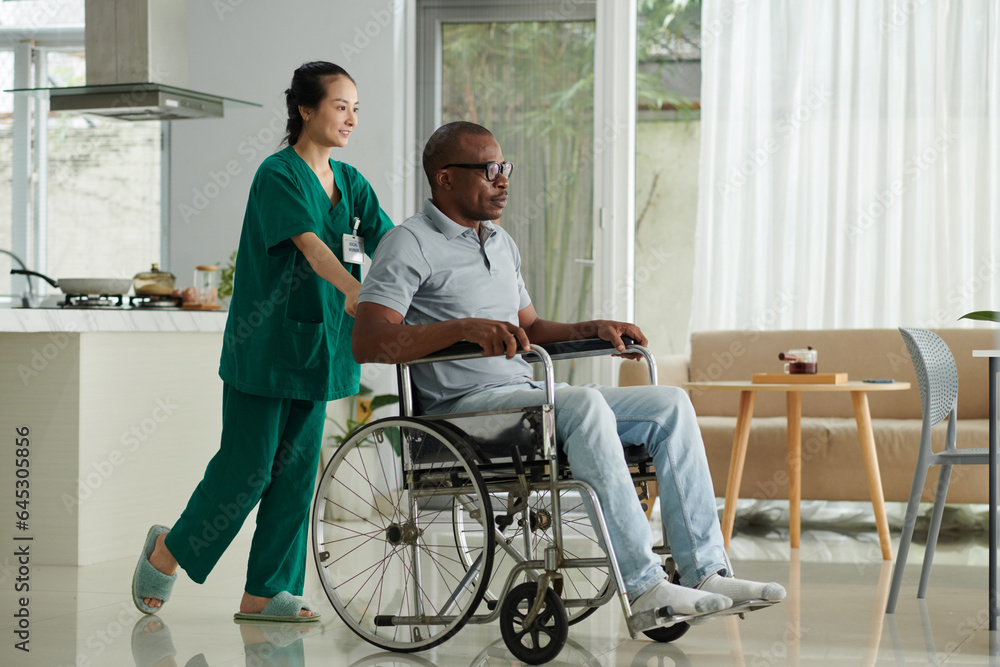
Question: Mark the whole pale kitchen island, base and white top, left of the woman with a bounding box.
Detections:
[0,318,226,566]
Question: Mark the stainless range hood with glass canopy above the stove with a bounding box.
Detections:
[48,0,260,120]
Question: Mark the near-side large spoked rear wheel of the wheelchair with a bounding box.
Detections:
[312,417,494,651]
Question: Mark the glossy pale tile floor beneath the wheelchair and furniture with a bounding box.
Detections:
[0,508,1000,667]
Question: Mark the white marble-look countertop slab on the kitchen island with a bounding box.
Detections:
[0,308,228,333]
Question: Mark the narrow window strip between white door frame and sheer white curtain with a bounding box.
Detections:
[635,0,701,354]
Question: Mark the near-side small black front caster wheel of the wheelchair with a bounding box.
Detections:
[500,582,569,665]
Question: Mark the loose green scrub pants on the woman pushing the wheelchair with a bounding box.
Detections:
[166,383,326,597]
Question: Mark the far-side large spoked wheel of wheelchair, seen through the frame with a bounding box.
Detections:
[453,489,612,625]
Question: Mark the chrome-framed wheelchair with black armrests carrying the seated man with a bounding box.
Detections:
[311,339,769,664]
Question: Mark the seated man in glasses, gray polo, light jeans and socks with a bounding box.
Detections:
[352,122,785,632]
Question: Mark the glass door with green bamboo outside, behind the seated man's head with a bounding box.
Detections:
[417,0,596,382]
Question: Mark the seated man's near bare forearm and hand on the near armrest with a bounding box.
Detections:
[351,302,531,364]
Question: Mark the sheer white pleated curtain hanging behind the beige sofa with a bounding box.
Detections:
[691,0,1000,331]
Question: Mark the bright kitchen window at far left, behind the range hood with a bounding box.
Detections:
[0,0,163,303]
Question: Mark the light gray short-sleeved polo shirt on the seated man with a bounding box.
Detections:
[358,199,531,412]
